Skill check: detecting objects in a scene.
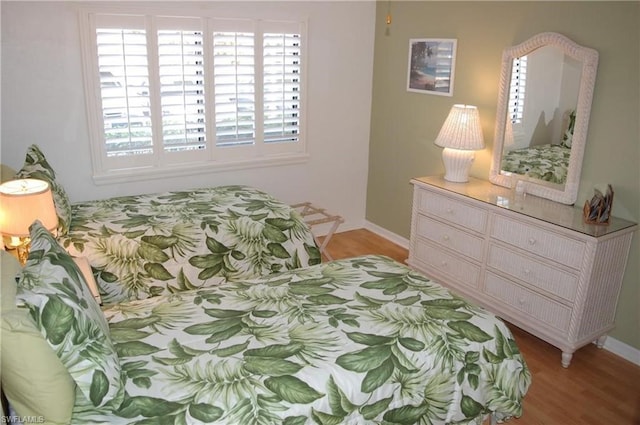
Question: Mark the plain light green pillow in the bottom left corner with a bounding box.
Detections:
[0,251,76,425]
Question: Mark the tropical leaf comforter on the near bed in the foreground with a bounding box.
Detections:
[73,256,531,425]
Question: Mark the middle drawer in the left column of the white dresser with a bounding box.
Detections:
[416,215,484,261]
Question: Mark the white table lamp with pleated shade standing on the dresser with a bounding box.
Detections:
[435,105,484,183]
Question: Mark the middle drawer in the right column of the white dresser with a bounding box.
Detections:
[487,244,578,302]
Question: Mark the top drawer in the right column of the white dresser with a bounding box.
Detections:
[491,215,585,269]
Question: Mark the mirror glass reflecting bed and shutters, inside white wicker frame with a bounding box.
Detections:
[500,46,582,185]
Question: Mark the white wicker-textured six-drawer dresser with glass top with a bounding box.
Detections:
[408,177,637,367]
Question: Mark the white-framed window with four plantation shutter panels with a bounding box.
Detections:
[82,11,306,181]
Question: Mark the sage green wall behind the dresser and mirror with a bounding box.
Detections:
[366,1,640,349]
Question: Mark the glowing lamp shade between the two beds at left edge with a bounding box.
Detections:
[0,179,58,237]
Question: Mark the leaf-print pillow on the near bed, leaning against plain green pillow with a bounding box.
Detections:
[16,221,123,407]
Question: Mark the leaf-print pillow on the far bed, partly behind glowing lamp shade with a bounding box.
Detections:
[16,145,71,236]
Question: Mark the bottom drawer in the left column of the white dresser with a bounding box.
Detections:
[412,239,480,288]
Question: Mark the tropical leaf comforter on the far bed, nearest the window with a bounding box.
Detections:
[60,186,320,304]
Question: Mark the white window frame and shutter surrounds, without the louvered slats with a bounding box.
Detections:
[79,7,310,184]
